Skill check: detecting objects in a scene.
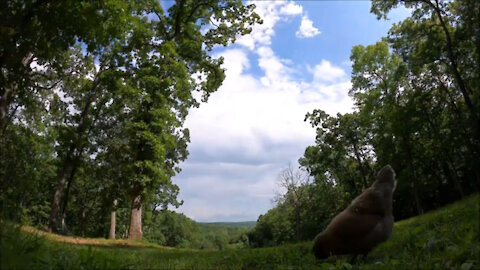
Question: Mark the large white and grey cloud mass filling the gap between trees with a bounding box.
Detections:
[174,1,353,221]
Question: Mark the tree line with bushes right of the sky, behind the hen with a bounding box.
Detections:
[249,0,480,246]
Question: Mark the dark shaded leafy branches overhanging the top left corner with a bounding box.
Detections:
[0,0,139,134]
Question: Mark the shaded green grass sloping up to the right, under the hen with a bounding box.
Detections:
[0,195,480,270]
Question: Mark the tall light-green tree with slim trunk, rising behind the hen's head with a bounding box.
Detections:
[350,42,423,213]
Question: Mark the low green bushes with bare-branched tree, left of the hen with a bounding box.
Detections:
[248,167,348,247]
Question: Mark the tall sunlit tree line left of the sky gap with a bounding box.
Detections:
[0,0,261,240]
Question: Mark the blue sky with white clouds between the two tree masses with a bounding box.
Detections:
[173,1,409,222]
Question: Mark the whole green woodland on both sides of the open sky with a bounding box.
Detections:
[0,0,480,269]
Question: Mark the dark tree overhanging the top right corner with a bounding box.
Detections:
[372,0,480,187]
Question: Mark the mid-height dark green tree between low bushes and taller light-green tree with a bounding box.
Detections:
[299,110,374,198]
